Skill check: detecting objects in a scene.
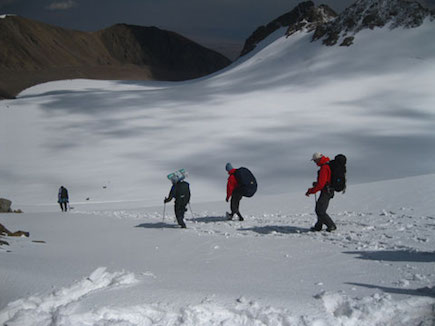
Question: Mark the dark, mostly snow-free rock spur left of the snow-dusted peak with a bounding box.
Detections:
[240,1,337,56]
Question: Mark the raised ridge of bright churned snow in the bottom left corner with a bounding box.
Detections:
[0,267,137,326]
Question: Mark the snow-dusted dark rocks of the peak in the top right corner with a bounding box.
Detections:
[313,0,435,45]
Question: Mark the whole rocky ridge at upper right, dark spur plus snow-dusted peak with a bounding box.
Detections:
[240,0,435,56]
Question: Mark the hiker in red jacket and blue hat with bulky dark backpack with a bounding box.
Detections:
[225,163,257,221]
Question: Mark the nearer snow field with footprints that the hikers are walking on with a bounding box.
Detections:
[0,175,435,326]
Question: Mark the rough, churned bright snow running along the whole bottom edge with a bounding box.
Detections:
[0,267,435,326]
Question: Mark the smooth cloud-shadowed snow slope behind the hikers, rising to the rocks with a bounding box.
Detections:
[0,21,435,205]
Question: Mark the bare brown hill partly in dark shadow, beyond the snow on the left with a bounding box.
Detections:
[0,15,231,98]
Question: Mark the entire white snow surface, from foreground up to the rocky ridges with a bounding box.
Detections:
[0,21,435,326]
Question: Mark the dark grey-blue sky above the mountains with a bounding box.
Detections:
[0,0,354,47]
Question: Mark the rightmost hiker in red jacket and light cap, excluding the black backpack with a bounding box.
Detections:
[305,153,337,232]
